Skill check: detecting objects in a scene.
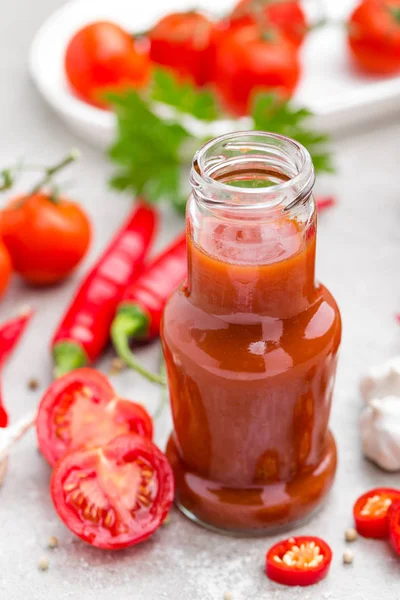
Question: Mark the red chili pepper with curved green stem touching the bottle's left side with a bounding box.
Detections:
[111,234,187,384]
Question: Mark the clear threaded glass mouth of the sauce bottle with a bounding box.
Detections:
[191,131,315,210]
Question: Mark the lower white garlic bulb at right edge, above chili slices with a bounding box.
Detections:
[360,396,400,471]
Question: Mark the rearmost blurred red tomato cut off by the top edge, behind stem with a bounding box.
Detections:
[230,0,307,47]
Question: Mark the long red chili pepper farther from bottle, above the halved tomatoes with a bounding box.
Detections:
[52,203,157,376]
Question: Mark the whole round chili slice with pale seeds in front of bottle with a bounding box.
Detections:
[266,536,332,586]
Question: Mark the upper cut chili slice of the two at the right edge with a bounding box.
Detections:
[353,488,400,539]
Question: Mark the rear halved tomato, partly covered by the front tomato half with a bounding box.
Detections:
[36,368,153,465]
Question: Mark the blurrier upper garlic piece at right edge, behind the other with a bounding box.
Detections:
[360,356,400,402]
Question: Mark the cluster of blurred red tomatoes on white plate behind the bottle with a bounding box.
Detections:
[65,0,307,115]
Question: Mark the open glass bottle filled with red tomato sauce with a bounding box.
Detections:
[162,132,341,535]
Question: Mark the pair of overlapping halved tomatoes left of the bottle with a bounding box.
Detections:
[36,368,174,550]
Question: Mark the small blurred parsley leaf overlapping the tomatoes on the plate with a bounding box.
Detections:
[150,69,219,121]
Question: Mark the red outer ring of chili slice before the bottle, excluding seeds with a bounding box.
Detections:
[266,536,332,586]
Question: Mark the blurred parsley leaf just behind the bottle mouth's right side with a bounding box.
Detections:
[252,94,334,173]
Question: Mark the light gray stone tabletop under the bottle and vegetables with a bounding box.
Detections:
[0,0,400,600]
